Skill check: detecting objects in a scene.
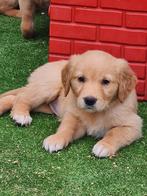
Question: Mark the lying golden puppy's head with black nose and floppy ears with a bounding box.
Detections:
[62,51,136,112]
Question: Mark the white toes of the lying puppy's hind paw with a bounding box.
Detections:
[11,114,32,126]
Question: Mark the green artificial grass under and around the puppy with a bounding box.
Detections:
[0,16,147,196]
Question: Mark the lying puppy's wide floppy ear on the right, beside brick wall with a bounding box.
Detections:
[117,59,137,102]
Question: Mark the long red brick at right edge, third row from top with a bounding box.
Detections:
[98,27,147,46]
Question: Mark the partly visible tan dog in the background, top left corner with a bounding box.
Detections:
[0,0,49,38]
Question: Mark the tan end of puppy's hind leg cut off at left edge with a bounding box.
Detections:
[0,95,16,115]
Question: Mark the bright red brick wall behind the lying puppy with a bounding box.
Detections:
[49,0,147,100]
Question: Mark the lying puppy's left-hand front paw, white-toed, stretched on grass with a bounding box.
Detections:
[43,134,68,153]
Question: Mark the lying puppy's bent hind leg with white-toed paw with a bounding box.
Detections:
[11,83,60,125]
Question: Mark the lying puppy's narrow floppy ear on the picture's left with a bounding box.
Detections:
[62,63,71,97]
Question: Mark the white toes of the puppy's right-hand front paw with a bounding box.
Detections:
[92,142,112,157]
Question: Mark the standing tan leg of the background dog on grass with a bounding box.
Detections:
[19,0,35,38]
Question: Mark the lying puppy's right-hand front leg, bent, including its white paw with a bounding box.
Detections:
[92,119,142,157]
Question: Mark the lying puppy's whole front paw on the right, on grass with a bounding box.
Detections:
[92,141,115,157]
